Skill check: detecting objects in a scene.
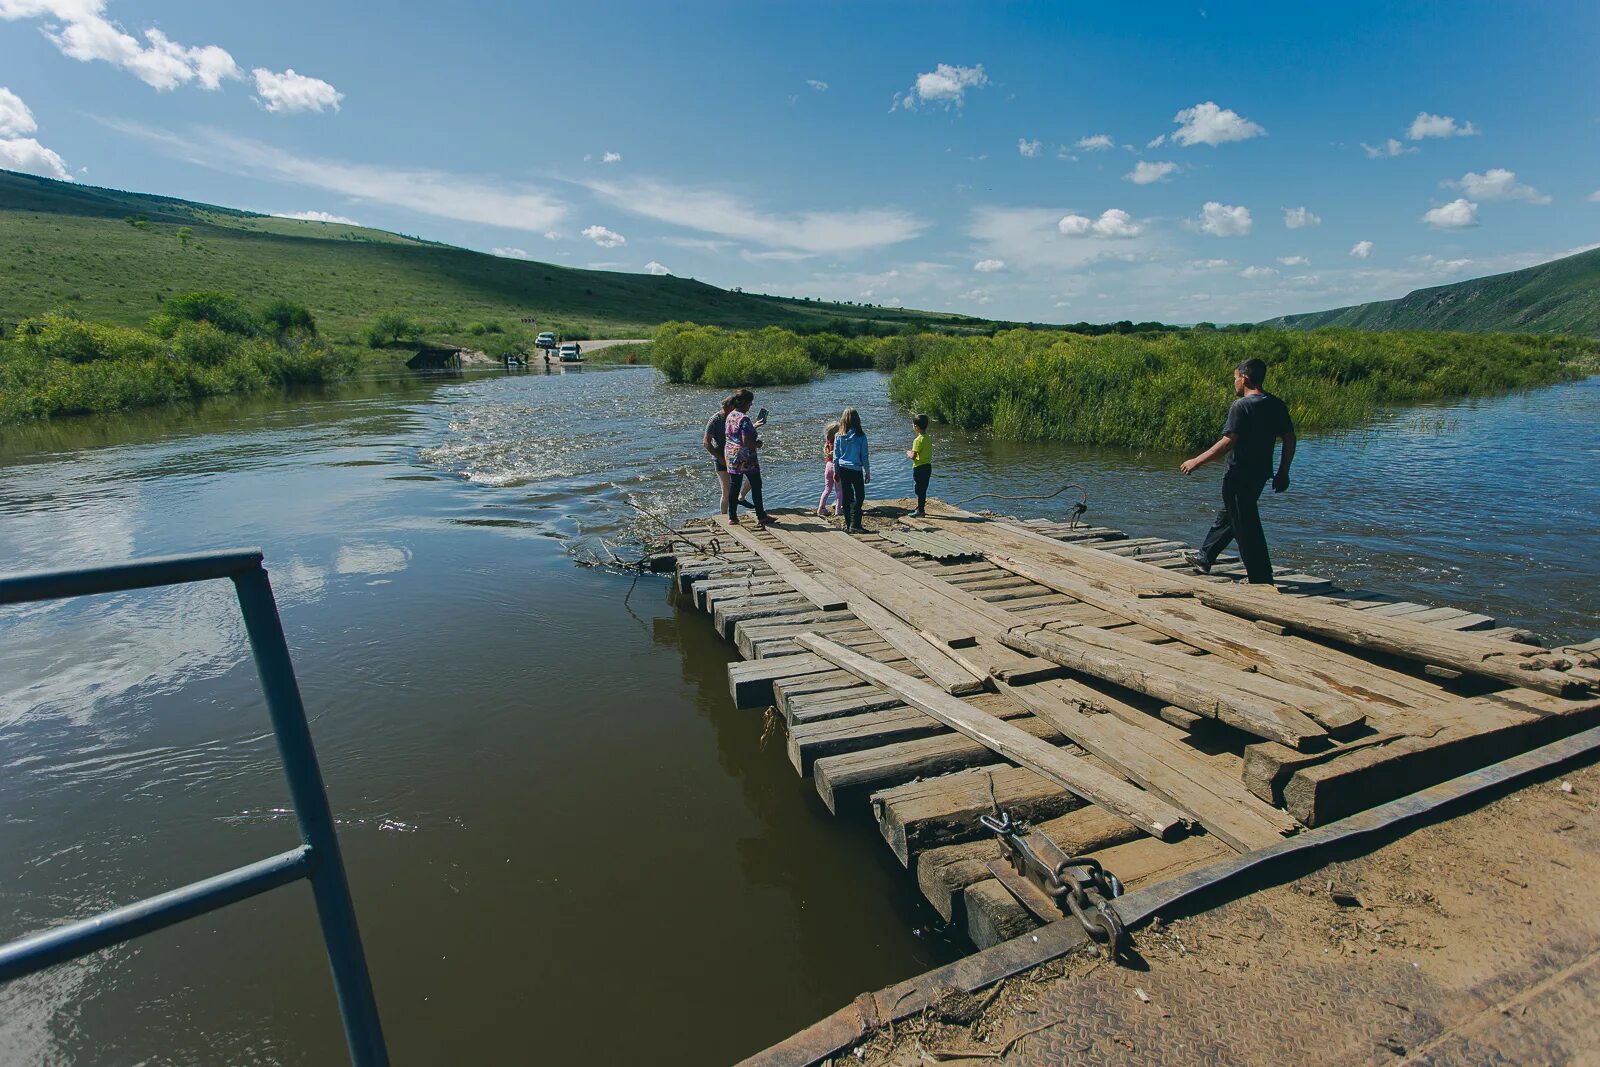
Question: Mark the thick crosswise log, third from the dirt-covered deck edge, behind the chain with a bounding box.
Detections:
[870,767,1083,867]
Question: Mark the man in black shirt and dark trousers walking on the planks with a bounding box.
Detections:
[1178,360,1294,585]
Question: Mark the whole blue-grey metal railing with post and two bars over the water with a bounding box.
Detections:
[0,549,389,1067]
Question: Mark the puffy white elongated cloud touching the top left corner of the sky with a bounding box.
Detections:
[0,0,240,90]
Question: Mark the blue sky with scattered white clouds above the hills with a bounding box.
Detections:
[0,0,1600,322]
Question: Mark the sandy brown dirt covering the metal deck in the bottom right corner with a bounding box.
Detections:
[838,765,1600,1065]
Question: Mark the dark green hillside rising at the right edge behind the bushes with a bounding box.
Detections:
[1261,248,1600,336]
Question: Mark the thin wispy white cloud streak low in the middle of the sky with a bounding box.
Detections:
[587,181,928,254]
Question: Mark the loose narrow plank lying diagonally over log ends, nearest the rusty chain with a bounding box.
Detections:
[797,633,1189,840]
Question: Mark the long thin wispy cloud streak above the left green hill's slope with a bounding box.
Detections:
[118,122,566,234]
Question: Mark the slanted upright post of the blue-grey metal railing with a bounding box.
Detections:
[232,563,389,1067]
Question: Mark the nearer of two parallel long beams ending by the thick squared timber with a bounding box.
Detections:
[998,629,1325,749]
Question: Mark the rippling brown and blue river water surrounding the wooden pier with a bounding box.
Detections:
[0,366,1600,1065]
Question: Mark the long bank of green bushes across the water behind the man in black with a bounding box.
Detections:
[888,321,1600,451]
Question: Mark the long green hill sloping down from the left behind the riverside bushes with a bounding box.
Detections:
[0,171,987,341]
